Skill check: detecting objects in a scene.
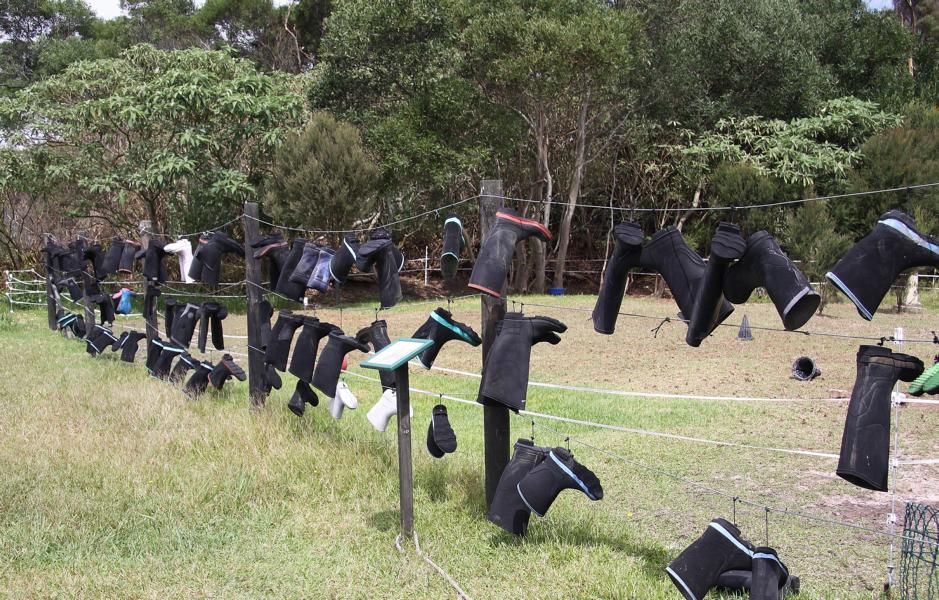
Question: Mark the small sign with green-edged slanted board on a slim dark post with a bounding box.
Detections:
[361,338,434,538]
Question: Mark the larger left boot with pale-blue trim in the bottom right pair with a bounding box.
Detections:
[665,519,753,600]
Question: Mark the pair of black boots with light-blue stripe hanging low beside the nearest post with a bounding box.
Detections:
[488,439,603,535]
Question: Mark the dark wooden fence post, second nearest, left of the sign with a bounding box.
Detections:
[243,202,267,407]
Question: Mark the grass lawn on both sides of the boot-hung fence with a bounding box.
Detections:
[0,296,939,599]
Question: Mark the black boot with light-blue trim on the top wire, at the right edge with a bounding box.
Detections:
[826,210,939,321]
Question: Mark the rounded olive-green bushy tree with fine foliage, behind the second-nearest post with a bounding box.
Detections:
[263,112,378,230]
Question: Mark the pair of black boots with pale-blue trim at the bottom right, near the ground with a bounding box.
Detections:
[665,518,798,600]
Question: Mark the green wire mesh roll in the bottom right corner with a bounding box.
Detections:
[900,502,939,600]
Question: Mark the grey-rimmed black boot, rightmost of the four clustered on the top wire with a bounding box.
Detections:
[724,231,821,331]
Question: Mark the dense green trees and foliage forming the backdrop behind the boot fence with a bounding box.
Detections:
[0,0,939,291]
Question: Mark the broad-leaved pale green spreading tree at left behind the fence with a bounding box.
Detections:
[0,46,305,236]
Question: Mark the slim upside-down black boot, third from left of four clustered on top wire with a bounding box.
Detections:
[685,223,747,348]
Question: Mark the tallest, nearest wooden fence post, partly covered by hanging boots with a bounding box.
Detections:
[479,179,511,508]
